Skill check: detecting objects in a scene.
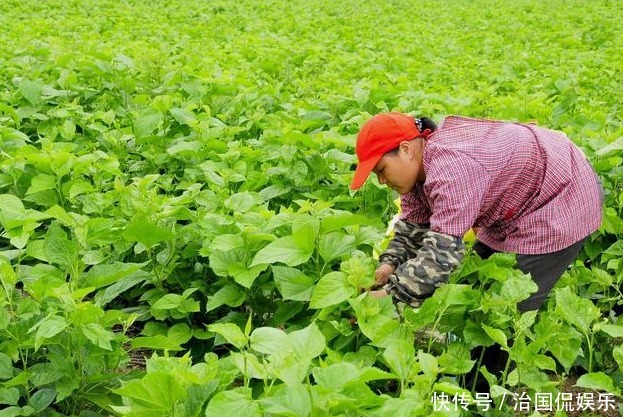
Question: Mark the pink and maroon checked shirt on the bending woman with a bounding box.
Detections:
[401,116,602,255]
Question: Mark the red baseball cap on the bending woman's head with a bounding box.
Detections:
[350,113,422,190]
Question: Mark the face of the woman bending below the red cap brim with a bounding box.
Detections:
[372,138,425,195]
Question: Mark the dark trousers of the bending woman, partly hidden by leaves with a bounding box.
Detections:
[468,239,586,386]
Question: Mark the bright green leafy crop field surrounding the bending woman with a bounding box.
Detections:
[0,0,623,417]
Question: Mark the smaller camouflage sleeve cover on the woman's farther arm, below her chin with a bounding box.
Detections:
[379,220,429,268]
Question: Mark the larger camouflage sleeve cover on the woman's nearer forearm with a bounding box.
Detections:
[384,231,465,307]
